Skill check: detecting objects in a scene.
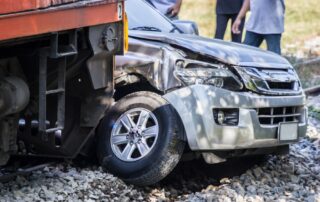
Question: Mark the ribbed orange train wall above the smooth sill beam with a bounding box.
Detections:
[0,0,80,15]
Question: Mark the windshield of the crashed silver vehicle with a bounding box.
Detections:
[126,0,179,33]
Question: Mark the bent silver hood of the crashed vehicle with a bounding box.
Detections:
[129,31,292,68]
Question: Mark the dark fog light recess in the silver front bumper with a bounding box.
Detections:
[213,109,239,126]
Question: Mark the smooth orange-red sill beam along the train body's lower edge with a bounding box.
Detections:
[0,0,124,41]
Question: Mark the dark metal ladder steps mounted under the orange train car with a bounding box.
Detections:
[38,30,78,144]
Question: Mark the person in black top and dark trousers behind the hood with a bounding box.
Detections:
[215,0,245,43]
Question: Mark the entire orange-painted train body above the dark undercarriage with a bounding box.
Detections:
[0,0,123,41]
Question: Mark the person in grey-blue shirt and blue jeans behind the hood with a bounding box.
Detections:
[232,0,285,55]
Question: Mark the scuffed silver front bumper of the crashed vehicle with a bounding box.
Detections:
[164,85,307,151]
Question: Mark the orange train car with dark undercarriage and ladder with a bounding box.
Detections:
[0,0,128,166]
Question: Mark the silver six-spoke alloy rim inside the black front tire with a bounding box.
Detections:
[110,108,159,162]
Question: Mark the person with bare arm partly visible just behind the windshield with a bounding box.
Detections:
[148,0,182,20]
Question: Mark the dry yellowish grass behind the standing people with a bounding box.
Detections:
[180,0,320,52]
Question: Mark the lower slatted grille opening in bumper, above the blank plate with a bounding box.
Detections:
[256,106,302,125]
